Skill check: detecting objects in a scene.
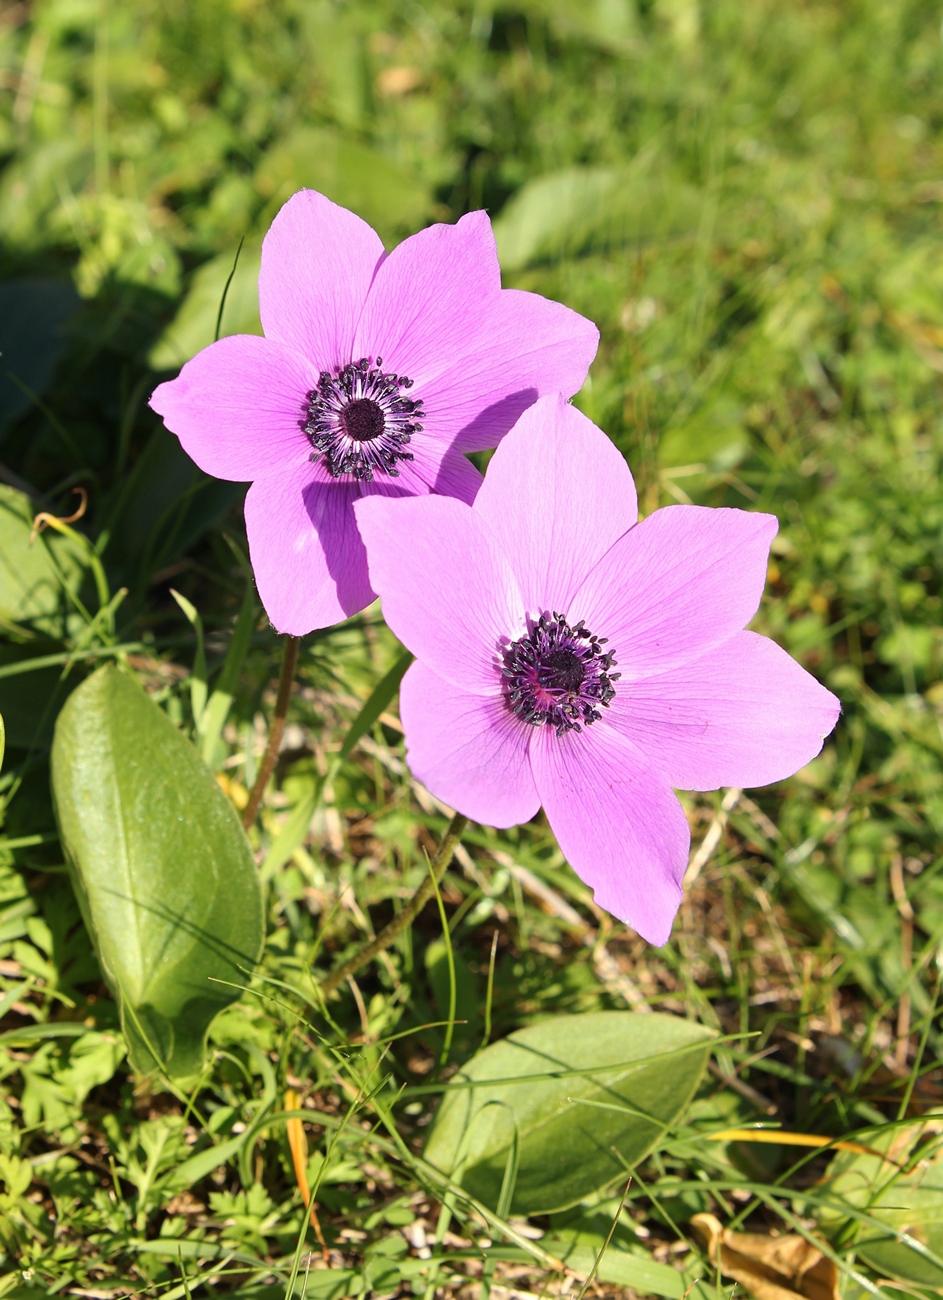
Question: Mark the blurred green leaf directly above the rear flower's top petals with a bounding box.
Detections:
[256,126,432,239]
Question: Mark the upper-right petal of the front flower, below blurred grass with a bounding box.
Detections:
[571,506,779,690]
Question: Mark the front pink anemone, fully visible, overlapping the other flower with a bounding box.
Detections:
[356,397,840,944]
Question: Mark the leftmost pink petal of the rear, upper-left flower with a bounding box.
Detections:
[151,334,317,482]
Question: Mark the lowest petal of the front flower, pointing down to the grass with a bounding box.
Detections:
[529,723,691,944]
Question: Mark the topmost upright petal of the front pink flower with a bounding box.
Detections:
[475,394,637,615]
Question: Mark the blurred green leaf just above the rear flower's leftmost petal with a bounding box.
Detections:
[147,244,261,371]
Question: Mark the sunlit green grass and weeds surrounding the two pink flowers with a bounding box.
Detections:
[0,0,943,1297]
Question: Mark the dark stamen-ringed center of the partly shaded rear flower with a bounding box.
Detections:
[302,356,424,482]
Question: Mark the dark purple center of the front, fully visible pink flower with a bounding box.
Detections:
[501,614,622,736]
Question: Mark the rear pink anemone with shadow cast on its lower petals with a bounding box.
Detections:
[151,190,598,636]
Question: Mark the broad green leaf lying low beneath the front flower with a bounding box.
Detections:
[425,1011,713,1214]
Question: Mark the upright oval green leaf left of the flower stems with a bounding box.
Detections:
[52,667,263,1078]
